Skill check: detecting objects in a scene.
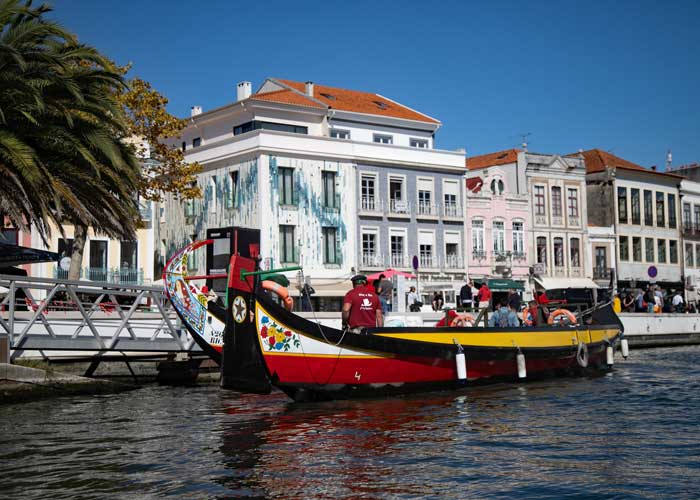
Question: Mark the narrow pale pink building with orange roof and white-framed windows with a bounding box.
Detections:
[465,149,531,290]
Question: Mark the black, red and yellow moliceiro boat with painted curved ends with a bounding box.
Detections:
[166,242,626,401]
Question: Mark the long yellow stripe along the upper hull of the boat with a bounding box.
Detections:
[375,328,620,349]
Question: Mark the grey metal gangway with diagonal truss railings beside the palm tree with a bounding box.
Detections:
[0,274,201,362]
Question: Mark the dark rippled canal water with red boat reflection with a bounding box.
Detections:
[0,347,700,499]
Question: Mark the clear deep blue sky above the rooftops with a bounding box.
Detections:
[51,0,700,169]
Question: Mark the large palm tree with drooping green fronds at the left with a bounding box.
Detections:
[0,0,140,279]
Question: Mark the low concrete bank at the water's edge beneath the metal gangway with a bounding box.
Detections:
[0,363,136,404]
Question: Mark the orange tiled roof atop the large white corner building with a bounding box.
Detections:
[275,79,440,123]
